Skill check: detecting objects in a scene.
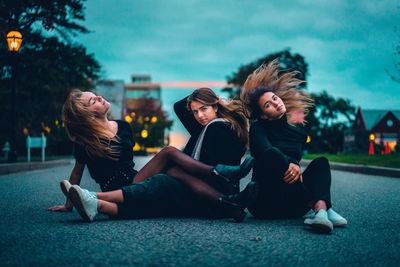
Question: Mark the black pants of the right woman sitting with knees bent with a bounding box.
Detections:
[249,149,331,219]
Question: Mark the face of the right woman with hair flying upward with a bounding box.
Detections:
[258,92,286,119]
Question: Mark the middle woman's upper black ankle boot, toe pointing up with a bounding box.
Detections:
[214,156,254,182]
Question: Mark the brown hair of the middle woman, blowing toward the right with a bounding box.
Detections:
[187,87,249,145]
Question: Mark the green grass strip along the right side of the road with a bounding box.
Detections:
[303,153,400,169]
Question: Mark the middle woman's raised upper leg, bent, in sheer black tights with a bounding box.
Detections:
[133,146,215,183]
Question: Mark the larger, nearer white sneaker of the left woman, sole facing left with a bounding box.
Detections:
[68,185,99,222]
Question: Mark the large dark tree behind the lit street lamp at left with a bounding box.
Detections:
[0,0,101,157]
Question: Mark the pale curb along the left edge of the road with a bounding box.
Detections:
[0,159,73,175]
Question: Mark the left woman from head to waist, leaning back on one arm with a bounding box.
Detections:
[49,89,137,211]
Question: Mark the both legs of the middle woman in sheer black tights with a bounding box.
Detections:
[133,146,221,202]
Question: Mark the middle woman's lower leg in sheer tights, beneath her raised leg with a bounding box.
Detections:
[166,167,221,203]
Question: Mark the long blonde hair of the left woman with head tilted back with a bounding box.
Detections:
[62,89,119,160]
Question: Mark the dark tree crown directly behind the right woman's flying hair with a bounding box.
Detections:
[224,49,308,99]
